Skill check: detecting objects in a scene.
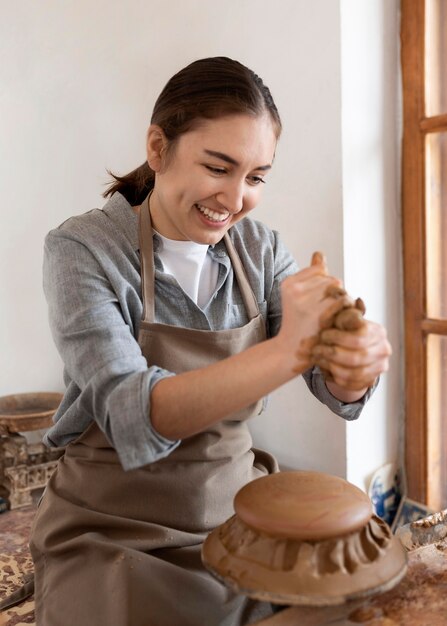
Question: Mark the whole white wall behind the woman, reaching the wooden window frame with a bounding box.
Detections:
[0,0,400,482]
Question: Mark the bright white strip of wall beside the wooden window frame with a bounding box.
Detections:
[341,0,403,486]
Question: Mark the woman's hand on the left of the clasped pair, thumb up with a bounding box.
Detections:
[277,252,352,373]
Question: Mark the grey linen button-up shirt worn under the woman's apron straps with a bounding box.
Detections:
[44,193,371,470]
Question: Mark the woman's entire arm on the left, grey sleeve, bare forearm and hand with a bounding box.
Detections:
[44,222,344,460]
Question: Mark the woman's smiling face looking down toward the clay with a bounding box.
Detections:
[148,114,276,244]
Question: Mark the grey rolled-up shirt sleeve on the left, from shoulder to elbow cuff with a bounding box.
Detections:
[43,228,179,470]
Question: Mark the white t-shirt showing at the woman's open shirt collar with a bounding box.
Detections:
[155,231,219,308]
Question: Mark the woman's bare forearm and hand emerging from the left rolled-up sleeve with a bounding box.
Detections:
[150,265,350,439]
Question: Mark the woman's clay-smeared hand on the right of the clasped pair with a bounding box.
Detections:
[312,320,391,392]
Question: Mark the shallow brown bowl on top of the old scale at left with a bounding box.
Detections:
[0,392,63,433]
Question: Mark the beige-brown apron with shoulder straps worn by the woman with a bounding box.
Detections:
[31,196,277,626]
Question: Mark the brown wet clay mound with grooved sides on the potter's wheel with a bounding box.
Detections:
[202,471,407,606]
